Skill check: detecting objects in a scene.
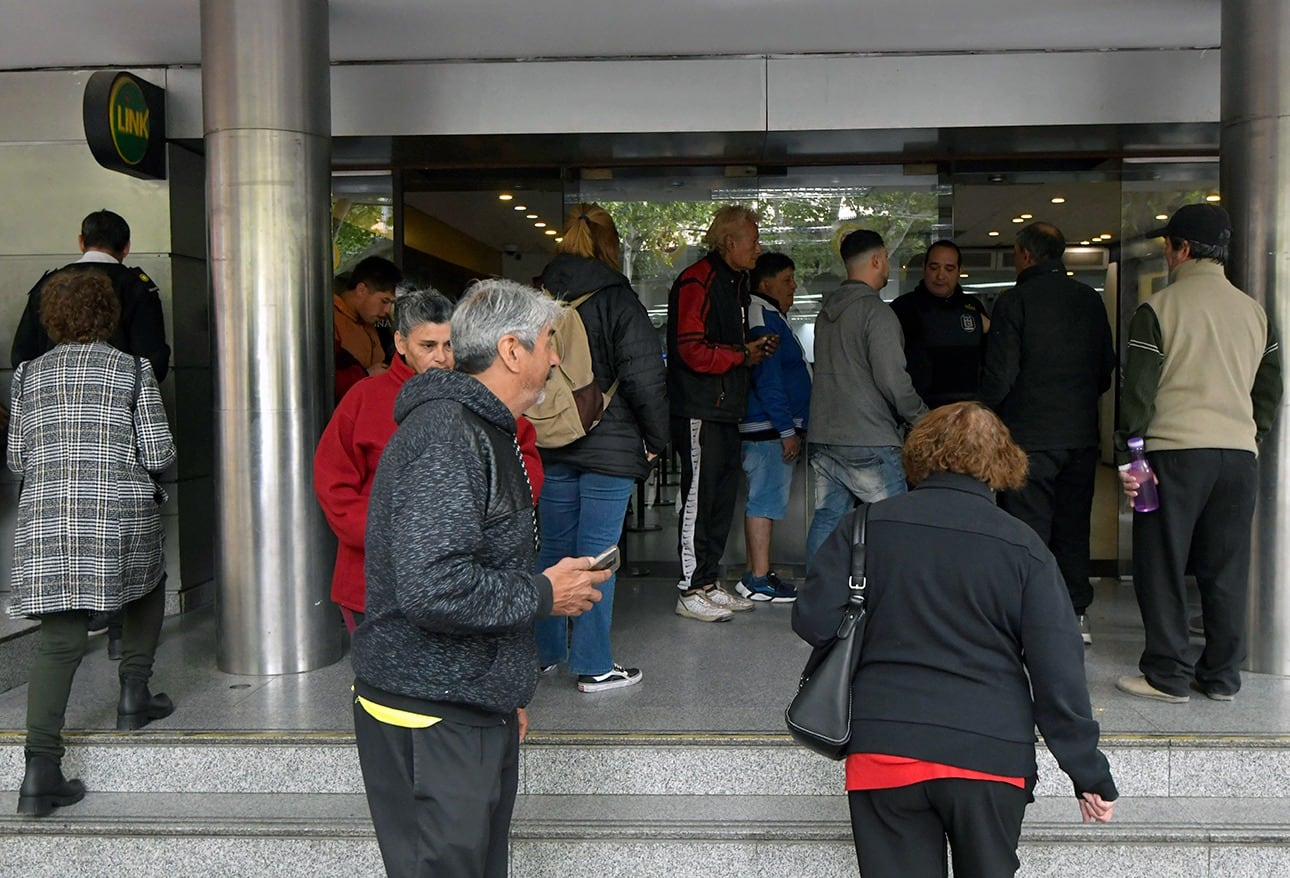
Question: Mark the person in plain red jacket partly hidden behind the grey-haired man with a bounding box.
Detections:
[313,289,542,633]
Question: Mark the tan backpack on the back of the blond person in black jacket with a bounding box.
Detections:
[524,289,618,449]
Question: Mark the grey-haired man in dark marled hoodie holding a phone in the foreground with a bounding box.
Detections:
[351,280,609,878]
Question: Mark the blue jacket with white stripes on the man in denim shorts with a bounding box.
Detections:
[739,293,810,440]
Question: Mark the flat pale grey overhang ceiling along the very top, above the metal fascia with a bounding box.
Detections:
[0,0,1222,70]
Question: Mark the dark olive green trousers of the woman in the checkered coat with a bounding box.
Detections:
[27,579,165,762]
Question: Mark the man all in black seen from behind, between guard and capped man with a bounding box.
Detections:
[980,223,1116,645]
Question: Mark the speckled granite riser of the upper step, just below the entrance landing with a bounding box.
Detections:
[0,731,1290,798]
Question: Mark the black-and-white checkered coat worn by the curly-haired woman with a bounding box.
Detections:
[8,342,174,618]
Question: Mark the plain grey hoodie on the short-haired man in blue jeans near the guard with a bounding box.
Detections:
[809,280,928,446]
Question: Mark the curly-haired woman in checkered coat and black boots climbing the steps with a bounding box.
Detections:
[8,269,174,816]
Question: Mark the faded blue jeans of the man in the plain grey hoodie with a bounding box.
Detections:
[806,442,908,565]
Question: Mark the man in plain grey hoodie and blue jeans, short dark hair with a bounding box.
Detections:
[806,228,928,563]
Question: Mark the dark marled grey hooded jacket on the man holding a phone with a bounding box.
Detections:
[351,369,552,716]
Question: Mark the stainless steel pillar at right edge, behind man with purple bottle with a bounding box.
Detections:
[1217,0,1290,674]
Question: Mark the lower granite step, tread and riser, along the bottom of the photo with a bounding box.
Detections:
[0,792,1290,878]
